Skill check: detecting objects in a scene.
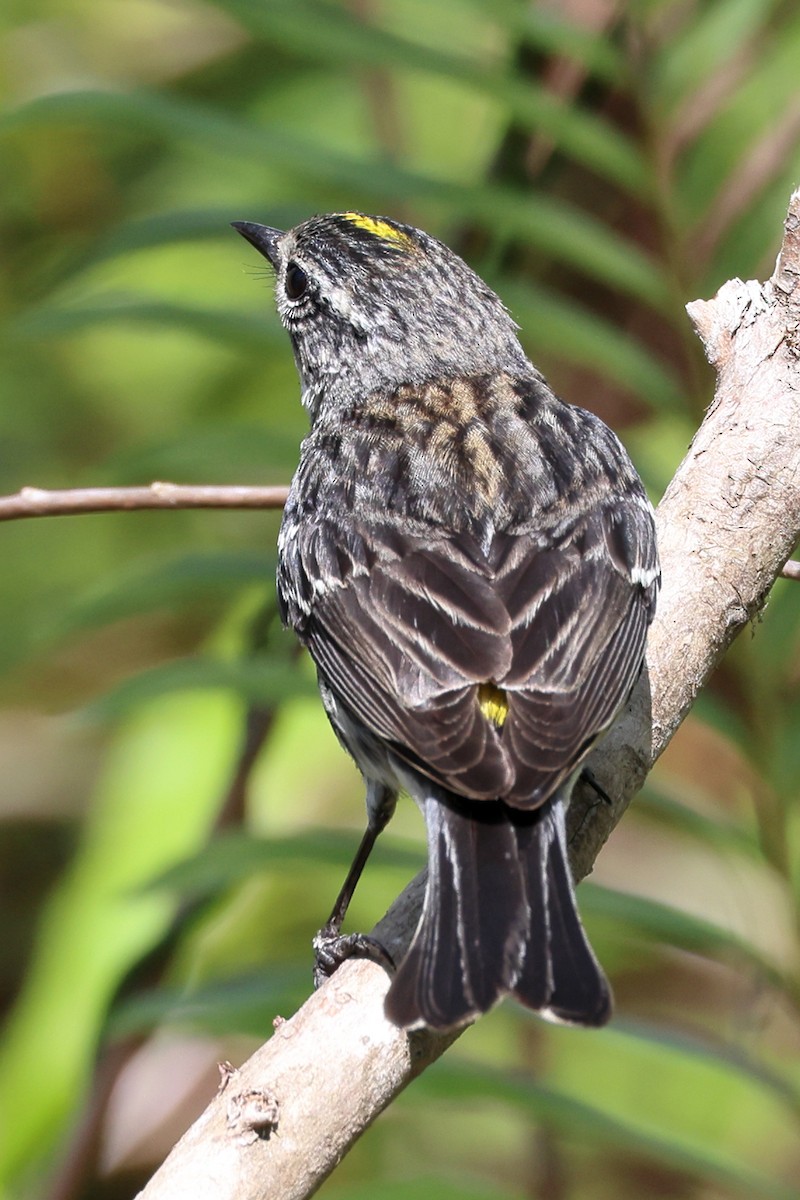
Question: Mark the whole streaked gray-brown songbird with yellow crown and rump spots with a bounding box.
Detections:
[235,212,660,1030]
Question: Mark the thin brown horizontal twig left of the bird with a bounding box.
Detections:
[0,482,289,521]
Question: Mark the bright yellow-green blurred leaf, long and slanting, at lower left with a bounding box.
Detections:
[0,695,239,1181]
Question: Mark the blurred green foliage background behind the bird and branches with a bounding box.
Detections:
[0,0,800,1200]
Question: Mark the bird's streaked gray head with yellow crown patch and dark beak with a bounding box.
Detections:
[235,212,534,414]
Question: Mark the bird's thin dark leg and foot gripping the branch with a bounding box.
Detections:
[312,784,397,988]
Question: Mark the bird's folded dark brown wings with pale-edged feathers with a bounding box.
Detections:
[299,487,655,808]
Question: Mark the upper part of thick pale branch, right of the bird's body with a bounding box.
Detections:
[571,182,800,876]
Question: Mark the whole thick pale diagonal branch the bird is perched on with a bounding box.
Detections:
[130,193,800,1200]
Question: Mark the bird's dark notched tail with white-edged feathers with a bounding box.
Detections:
[386,793,612,1030]
